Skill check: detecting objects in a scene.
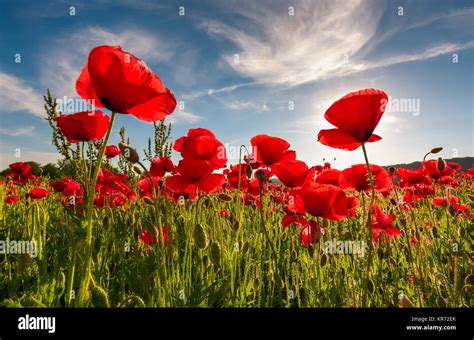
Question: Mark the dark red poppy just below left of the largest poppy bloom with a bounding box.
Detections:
[56,110,110,143]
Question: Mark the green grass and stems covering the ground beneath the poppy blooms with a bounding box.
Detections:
[0,179,474,307]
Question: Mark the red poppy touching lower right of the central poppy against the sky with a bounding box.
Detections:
[272,160,315,188]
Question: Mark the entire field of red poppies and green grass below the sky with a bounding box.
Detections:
[0,46,474,307]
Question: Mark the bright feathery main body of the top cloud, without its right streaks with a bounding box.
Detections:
[201,0,384,85]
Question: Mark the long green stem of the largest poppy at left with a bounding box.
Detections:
[78,112,115,307]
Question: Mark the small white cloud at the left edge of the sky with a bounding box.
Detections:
[0,72,46,118]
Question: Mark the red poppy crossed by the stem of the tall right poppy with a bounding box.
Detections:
[339,164,392,191]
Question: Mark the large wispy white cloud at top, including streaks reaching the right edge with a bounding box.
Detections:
[200,0,474,86]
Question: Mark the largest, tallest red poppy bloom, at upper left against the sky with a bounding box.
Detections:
[76,46,176,122]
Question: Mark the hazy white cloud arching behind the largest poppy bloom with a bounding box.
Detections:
[41,26,173,97]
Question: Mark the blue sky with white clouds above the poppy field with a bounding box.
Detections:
[0,0,474,168]
